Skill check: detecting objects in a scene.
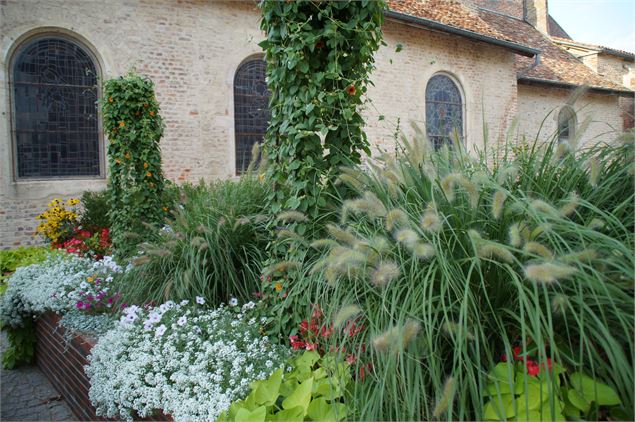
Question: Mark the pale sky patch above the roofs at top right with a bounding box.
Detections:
[548,0,635,53]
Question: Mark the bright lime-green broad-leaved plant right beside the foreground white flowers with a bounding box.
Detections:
[218,352,353,422]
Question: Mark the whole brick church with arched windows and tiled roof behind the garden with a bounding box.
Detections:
[0,0,635,248]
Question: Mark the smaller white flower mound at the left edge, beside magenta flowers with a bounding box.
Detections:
[0,254,123,327]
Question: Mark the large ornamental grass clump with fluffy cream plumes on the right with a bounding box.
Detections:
[288,130,635,420]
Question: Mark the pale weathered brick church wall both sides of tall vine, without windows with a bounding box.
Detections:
[0,0,628,249]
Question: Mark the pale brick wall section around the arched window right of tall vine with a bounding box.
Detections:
[365,21,516,155]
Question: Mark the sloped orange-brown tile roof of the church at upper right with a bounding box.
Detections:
[388,0,630,92]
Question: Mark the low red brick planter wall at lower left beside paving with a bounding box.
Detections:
[35,312,172,421]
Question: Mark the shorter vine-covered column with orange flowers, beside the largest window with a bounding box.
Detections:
[103,72,165,254]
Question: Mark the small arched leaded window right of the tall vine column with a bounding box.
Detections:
[426,75,463,148]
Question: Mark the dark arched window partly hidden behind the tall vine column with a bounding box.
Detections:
[234,58,269,174]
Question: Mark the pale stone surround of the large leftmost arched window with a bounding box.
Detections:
[5,27,107,183]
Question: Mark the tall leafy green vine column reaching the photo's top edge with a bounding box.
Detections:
[260,0,386,221]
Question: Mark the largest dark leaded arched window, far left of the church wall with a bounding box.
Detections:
[11,35,101,178]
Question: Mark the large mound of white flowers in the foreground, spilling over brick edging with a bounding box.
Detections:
[85,298,288,421]
